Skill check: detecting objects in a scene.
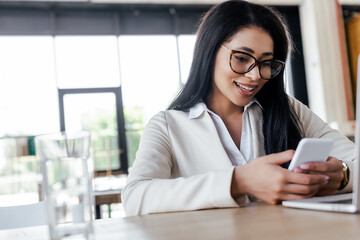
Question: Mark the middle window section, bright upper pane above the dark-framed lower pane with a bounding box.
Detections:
[55,36,127,174]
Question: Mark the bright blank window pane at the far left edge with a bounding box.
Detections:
[0,36,60,136]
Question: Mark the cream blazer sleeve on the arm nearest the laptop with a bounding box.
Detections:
[289,97,355,192]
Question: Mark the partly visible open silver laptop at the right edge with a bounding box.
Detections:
[282,55,360,213]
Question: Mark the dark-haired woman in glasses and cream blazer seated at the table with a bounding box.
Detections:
[122,1,354,215]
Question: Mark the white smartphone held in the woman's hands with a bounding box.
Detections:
[288,138,334,171]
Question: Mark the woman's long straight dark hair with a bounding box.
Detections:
[168,0,302,158]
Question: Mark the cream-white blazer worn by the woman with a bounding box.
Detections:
[121,97,355,216]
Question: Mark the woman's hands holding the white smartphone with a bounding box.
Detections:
[239,150,341,204]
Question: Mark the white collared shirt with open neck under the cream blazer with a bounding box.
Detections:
[189,99,261,166]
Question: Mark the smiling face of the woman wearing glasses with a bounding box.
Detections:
[207,28,282,109]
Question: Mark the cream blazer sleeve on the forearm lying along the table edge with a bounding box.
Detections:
[121,112,239,216]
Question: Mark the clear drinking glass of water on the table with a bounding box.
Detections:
[35,131,94,240]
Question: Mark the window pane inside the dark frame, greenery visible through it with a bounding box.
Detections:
[64,93,123,171]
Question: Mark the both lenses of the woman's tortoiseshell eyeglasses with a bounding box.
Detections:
[231,53,283,79]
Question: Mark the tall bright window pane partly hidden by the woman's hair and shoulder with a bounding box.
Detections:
[119,35,180,166]
